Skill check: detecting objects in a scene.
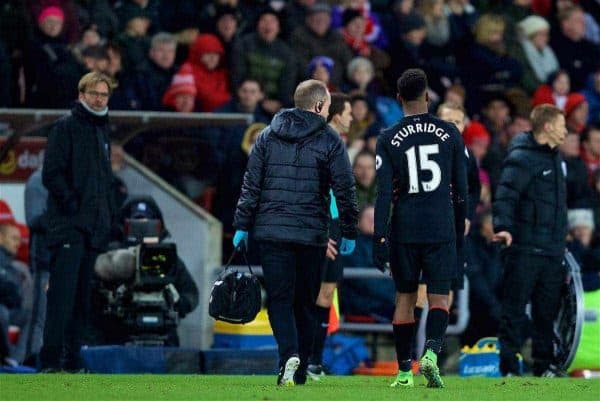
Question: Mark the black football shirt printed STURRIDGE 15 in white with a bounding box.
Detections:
[375,114,467,243]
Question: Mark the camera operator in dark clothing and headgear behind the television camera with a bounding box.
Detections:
[91,196,198,346]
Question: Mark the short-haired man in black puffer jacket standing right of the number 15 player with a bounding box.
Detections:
[493,105,567,376]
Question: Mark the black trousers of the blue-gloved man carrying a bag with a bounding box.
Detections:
[260,241,325,369]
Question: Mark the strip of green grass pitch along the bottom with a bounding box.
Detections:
[0,374,600,401]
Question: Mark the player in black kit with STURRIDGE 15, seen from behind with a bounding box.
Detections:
[373,69,467,387]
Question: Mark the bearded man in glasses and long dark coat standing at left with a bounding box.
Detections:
[40,72,113,372]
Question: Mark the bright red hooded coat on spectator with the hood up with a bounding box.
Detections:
[181,34,231,112]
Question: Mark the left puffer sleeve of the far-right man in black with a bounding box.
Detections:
[493,151,534,235]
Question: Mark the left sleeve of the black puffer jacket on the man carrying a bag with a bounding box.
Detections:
[233,127,269,231]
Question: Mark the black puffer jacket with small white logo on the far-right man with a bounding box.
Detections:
[493,132,567,256]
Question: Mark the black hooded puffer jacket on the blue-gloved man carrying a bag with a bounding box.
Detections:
[233,109,358,246]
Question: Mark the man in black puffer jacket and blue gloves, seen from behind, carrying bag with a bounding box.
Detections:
[233,80,358,386]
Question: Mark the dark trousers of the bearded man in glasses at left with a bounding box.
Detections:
[40,237,98,369]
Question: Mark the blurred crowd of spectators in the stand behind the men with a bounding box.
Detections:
[0,0,600,368]
